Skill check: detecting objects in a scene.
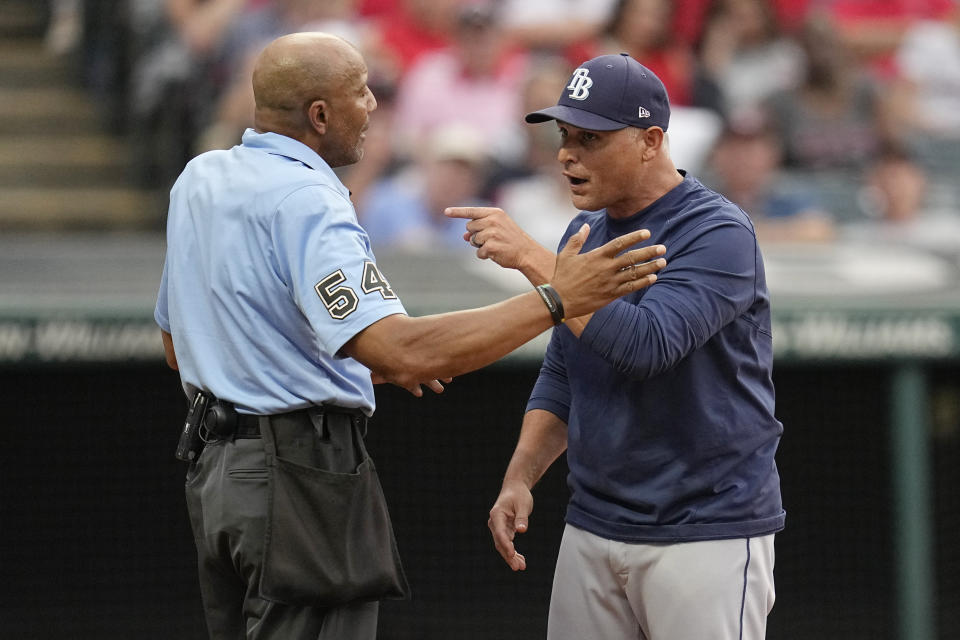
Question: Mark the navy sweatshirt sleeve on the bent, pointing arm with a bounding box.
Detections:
[580,220,758,379]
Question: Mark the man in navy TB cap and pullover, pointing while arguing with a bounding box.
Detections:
[448,54,785,640]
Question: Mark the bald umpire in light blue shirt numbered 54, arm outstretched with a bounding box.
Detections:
[155,33,664,640]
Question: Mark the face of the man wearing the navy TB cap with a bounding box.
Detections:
[557,121,650,218]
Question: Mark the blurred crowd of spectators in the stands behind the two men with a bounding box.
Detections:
[47,0,960,258]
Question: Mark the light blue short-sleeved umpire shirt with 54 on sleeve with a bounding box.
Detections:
[154,129,405,415]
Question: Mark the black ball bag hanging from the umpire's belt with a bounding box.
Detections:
[260,412,409,607]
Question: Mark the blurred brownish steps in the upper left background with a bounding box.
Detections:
[0,0,163,231]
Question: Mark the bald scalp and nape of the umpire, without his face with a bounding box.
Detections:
[253,33,366,138]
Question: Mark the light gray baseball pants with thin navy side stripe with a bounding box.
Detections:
[547,525,774,640]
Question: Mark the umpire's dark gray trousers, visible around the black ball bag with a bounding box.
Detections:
[186,427,379,640]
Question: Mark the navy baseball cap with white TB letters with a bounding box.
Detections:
[525,53,670,131]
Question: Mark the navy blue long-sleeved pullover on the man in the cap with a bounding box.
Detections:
[527,176,785,542]
